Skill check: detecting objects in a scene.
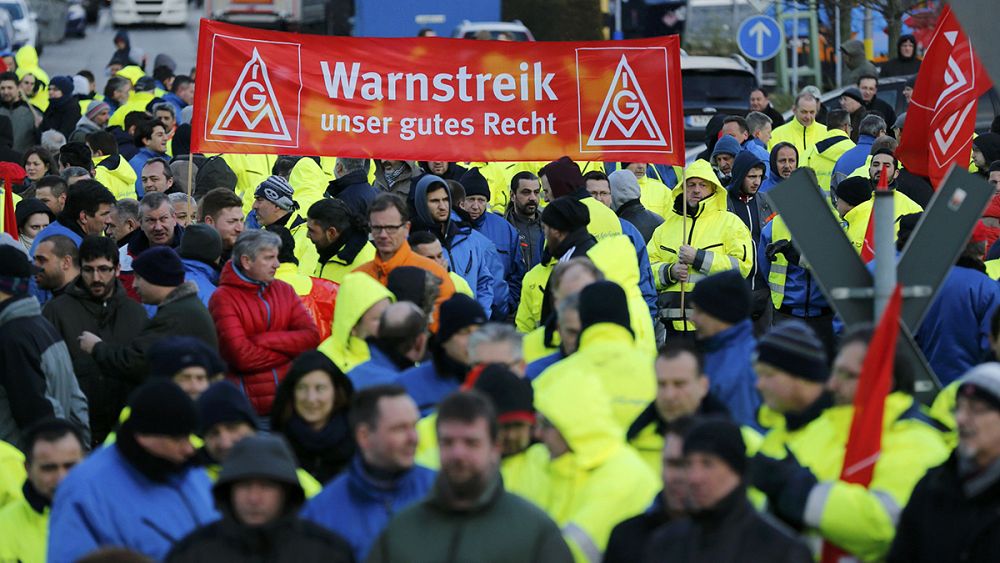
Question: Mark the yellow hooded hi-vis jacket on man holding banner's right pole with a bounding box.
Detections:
[646,160,756,331]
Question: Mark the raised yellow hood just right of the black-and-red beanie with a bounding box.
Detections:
[535,373,625,469]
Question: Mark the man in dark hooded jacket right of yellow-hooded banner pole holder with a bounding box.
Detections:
[726,151,774,336]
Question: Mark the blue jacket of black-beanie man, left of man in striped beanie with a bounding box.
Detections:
[701,319,760,428]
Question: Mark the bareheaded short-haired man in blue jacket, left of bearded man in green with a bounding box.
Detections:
[302,385,435,561]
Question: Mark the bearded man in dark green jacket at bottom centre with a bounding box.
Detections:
[368,391,573,563]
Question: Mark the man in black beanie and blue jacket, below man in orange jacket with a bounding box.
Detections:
[396,294,487,416]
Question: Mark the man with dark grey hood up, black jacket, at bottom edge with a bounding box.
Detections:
[166,435,354,563]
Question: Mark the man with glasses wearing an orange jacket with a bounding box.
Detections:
[357,193,455,331]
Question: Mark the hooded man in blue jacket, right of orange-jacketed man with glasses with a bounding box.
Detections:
[410,174,510,318]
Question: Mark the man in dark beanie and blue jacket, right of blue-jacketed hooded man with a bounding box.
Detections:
[460,168,526,318]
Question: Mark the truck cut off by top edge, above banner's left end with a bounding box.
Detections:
[205,0,331,33]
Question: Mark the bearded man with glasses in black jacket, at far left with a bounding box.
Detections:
[42,235,147,445]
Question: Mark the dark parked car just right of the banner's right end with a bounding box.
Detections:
[681,55,757,146]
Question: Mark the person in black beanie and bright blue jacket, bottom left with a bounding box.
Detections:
[48,379,219,563]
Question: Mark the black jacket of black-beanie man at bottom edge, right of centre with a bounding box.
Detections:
[642,487,813,563]
